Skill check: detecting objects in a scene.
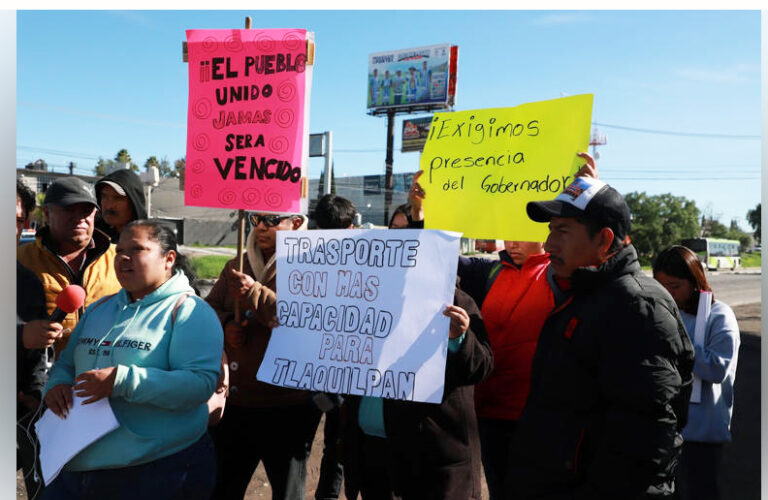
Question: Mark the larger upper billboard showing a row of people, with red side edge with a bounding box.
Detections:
[366,44,459,112]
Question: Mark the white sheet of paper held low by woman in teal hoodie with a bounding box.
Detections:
[35,394,120,486]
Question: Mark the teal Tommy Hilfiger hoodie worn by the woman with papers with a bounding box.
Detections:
[45,272,224,471]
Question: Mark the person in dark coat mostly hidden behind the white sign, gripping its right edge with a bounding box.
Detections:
[343,207,493,500]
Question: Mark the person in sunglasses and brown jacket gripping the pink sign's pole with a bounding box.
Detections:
[206,213,321,500]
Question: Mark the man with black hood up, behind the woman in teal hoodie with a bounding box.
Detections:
[96,168,147,243]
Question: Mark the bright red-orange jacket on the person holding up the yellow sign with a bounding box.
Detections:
[475,254,554,420]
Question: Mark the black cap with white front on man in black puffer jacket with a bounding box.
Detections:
[526,177,631,241]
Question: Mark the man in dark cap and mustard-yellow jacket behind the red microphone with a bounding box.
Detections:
[16,177,121,357]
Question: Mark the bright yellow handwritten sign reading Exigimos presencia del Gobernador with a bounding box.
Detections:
[419,94,593,241]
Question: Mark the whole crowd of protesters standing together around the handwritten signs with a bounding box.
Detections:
[16,153,739,500]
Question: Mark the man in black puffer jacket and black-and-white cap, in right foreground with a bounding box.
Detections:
[504,177,693,500]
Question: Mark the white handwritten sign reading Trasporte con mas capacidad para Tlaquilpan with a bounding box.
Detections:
[256,229,461,403]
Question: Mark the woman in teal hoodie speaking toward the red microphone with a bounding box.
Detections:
[42,220,223,500]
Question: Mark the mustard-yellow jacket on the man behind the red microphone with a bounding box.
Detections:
[16,228,121,358]
